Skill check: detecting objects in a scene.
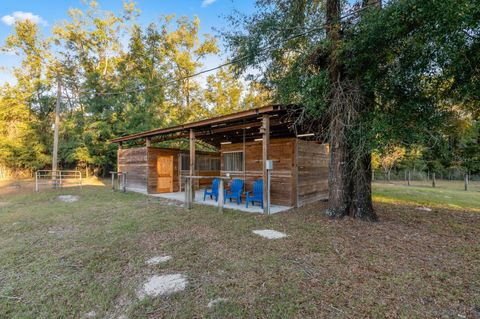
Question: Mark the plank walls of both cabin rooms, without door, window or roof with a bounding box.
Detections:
[117,142,329,206]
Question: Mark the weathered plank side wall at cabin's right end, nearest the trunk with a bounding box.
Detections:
[297,140,329,206]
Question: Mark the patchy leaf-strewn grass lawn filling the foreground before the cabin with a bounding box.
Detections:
[0,185,480,318]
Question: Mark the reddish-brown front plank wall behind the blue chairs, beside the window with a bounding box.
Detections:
[221,138,296,206]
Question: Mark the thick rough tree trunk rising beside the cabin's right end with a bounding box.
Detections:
[326,0,380,221]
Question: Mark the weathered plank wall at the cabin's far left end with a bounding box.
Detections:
[117,147,147,191]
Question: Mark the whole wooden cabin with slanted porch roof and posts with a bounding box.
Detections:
[112,105,329,207]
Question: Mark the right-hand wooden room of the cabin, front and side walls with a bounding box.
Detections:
[220,138,328,207]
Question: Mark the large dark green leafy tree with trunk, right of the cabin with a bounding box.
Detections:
[224,0,480,219]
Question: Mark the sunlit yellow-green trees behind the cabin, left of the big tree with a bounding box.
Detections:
[0,1,268,178]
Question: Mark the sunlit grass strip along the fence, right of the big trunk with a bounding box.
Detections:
[373,181,480,211]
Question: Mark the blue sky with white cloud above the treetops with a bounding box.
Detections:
[0,0,254,85]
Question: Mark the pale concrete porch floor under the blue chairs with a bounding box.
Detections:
[149,190,291,214]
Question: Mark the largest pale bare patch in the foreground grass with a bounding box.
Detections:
[137,274,187,299]
